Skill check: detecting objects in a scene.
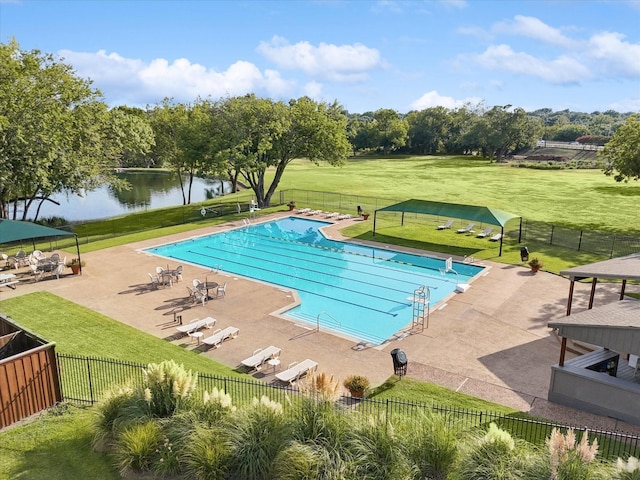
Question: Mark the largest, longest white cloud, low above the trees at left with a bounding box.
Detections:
[59,50,295,104]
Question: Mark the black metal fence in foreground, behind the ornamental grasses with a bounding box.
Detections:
[57,354,640,459]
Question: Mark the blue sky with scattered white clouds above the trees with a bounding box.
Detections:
[0,0,640,113]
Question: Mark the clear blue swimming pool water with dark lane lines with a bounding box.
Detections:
[147,217,482,344]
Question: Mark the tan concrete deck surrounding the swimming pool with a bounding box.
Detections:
[0,212,640,433]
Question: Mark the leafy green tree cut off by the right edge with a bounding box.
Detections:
[598,115,640,182]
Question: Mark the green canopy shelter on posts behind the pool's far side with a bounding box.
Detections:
[373,199,522,256]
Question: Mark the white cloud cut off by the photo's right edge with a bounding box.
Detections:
[586,32,640,78]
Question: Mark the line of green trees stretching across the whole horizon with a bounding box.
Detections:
[0,40,640,220]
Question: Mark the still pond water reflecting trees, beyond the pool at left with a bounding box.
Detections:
[28,172,231,221]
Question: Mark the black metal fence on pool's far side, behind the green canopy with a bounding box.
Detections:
[279,189,640,258]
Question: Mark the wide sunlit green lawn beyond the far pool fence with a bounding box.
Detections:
[279,156,640,236]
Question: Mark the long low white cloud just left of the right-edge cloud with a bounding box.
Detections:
[473,44,592,84]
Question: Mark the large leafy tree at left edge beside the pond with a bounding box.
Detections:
[0,41,153,219]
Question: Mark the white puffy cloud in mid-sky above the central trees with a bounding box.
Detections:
[257,36,383,82]
